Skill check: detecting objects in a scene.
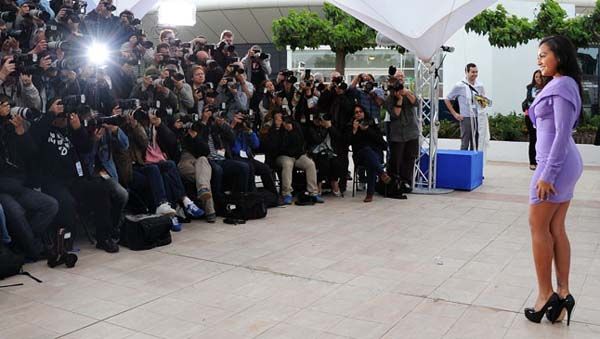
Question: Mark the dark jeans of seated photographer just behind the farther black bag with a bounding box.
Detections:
[209,159,254,194]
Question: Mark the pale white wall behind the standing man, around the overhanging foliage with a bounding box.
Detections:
[443,0,575,114]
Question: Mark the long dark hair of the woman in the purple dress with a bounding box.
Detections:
[540,35,583,115]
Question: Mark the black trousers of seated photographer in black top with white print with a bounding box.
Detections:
[42,178,115,241]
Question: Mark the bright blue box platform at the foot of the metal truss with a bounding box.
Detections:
[421,149,483,191]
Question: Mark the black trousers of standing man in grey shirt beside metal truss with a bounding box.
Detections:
[388,139,419,184]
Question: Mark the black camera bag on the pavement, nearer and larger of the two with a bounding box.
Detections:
[119,215,173,251]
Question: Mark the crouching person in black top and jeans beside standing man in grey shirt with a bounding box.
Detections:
[346,105,391,202]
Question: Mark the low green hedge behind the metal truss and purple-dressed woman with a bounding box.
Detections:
[424,112,600,144]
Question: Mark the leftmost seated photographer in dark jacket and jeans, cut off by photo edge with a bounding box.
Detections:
[0,95,58,261]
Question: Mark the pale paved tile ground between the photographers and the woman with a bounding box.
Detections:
[0,163,600,339]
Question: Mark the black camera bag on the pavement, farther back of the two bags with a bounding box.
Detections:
[217,192,267,220]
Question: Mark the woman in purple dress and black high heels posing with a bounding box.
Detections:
[525,36,583,325]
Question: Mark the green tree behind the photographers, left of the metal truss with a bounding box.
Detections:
[273,3,377,74]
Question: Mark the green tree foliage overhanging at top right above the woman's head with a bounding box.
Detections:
[465,0,600,47]
